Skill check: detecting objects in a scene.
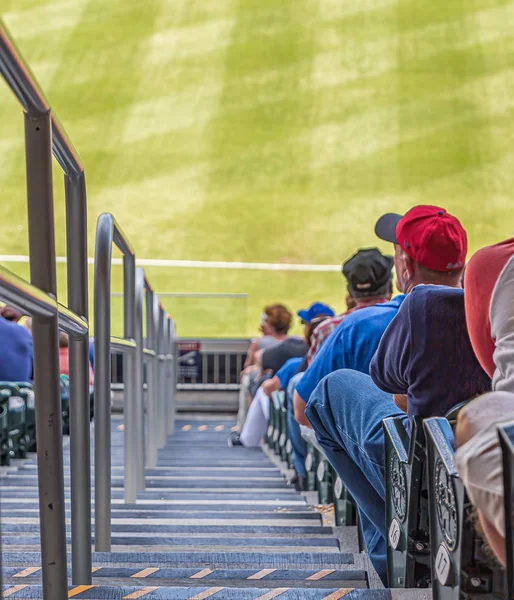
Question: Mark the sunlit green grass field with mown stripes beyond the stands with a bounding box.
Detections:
[0,0,514,335]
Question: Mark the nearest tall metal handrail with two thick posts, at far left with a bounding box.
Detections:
[0,19,91,600]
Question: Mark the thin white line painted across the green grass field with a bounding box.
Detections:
[0,254,341,273]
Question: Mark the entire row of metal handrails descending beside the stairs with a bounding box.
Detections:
[0,20,176,600]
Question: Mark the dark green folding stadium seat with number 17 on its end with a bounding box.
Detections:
[424,417,505,600]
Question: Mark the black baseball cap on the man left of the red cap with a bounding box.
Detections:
[342,248,394,297]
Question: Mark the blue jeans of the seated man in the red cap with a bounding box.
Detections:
[306,369,407,587]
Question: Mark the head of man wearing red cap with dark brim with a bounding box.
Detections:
[375,205,468,293]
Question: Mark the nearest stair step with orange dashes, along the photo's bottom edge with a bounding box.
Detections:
[4,585,391,600]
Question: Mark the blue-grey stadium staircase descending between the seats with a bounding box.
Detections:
[0,415,430,600]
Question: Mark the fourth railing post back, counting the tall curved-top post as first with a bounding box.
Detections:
[146,286,159,469]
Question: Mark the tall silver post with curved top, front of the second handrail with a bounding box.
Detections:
[94,215,113,552]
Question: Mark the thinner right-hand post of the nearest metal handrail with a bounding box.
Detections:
[64,173,91,585]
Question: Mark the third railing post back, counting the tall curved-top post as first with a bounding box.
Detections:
[134,268,145,491]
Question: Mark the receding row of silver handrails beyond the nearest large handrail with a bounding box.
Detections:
[94,213,175,552]
